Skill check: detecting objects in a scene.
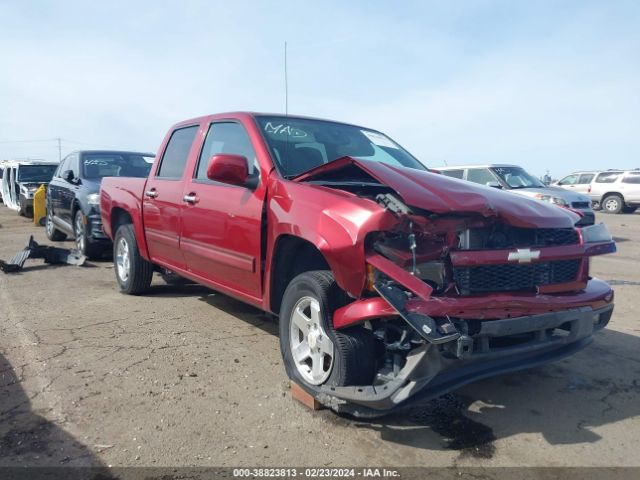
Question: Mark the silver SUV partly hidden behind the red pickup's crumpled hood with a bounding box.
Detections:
[436,164,596,226]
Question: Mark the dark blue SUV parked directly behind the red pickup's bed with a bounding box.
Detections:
[45,150,154,258]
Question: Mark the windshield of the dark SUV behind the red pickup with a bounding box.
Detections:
[82,153,153,179]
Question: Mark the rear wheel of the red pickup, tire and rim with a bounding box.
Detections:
[113,224,153,295]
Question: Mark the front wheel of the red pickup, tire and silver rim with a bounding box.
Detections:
[279,270,376,395]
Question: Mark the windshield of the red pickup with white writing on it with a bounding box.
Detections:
[257,117,427,178]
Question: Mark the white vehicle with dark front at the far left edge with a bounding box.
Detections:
[0,160,58,215]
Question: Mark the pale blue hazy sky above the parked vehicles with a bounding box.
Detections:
[0,0,640,177]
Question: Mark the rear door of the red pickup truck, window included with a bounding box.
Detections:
[142,125,199,270]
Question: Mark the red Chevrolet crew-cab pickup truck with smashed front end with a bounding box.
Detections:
[101,112,616,416]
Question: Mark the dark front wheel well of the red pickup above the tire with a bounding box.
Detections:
[270,235,330,314]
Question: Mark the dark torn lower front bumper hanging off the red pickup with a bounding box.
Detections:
[317,303,613,417]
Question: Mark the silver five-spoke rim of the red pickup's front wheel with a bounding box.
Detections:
[289,297,334,385]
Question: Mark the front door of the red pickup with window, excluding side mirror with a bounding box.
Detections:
[180,120,266,303]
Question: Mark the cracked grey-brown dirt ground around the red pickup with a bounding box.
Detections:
[0,207,640,467]
